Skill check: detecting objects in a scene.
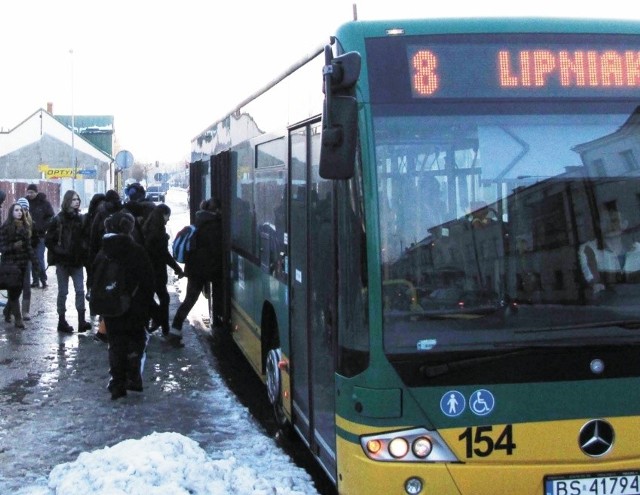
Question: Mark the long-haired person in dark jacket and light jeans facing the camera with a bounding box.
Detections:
[45,190,91,333]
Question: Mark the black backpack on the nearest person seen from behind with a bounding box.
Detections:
[89,252,138,316]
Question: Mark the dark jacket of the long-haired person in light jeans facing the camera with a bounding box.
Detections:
[44,211,89,267]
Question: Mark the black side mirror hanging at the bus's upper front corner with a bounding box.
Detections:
[320,45,360,179]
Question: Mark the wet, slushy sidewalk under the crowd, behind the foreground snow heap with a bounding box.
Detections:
[0,267,218,493]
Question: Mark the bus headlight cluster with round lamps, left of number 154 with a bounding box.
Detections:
[360,428,458,462]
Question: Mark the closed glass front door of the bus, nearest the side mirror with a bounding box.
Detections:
[288,123,335,473]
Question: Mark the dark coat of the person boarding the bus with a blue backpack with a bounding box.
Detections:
[185,210,224,281]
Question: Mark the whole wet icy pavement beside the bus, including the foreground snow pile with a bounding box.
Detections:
[0,190,318,495]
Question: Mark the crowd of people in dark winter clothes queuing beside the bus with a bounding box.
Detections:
[0,184,222,400]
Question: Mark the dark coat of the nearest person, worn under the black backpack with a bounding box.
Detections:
[94,234,154,324]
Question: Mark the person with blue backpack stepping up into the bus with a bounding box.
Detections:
[167,199,223,347]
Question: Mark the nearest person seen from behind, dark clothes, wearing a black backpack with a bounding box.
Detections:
[89,211,154,400]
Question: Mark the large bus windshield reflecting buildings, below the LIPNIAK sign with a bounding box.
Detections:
[373,100,640,354]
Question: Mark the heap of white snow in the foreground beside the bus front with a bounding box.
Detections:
[16,432,317,495]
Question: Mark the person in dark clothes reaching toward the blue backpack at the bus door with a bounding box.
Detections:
[142,203,184,335]
